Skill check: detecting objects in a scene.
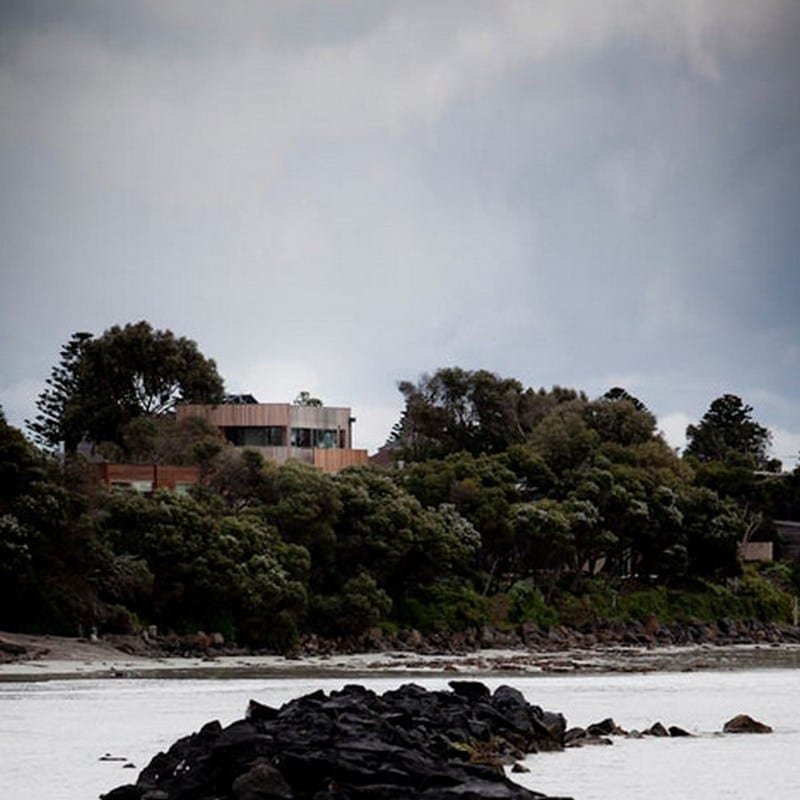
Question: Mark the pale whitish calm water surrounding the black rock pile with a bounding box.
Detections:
[0,669,800,800]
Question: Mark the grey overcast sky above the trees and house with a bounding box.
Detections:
[0,0,800,466]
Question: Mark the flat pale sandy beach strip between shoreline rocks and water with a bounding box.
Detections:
[0,633,800,683]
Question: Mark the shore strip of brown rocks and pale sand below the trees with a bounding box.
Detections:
[0,621,800,681]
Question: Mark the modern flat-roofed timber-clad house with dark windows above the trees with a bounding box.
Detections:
[177,395,368,472]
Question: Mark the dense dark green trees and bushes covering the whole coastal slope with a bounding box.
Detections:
[0,323,800,648]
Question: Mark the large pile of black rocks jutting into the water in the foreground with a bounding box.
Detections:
[103,681,566,800]
